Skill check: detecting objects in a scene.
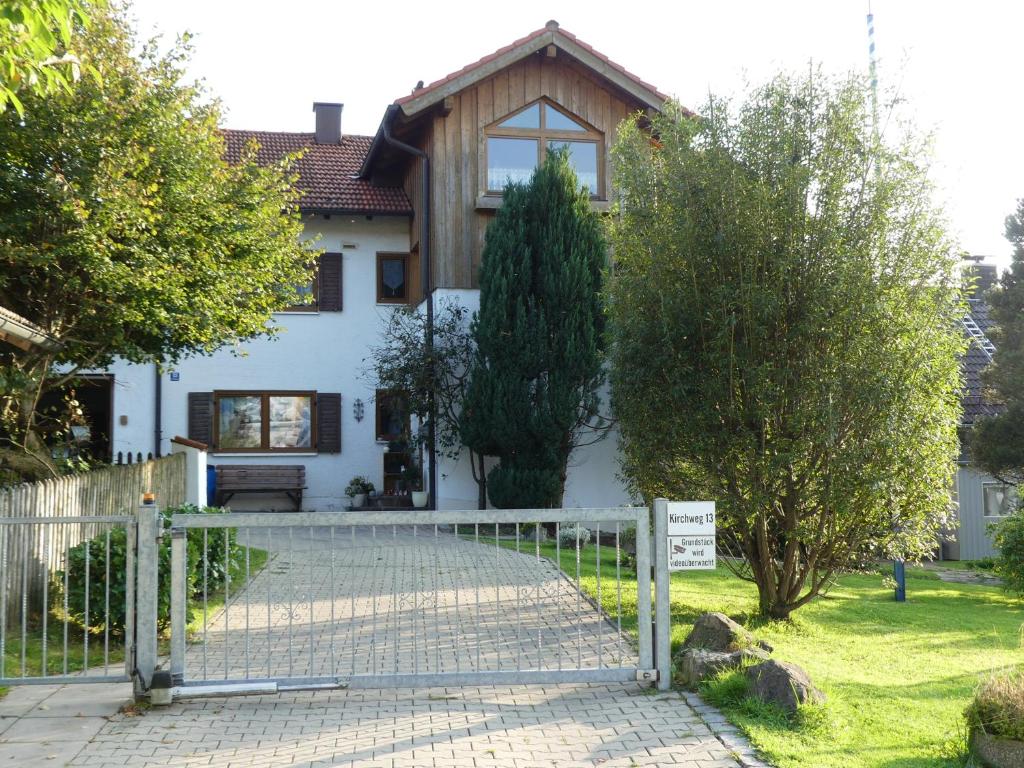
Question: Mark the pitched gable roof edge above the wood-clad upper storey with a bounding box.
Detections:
[395,20,668,117]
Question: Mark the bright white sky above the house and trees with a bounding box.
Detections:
[131,0,1024,267]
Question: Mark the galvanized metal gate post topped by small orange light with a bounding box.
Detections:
[134,497,161,696]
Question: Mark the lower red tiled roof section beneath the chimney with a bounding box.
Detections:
[224,129,413,215]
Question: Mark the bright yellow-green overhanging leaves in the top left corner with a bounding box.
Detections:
[0,0,99,115]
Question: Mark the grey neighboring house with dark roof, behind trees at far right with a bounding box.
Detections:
[942,264,1016,560]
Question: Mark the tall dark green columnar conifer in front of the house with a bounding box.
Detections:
[461,152,606,508]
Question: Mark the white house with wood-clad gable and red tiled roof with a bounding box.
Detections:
[101,22,666,510]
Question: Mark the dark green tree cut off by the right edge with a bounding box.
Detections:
[972,199,1024,485]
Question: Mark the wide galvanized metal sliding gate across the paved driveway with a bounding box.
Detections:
[163,507,656,696]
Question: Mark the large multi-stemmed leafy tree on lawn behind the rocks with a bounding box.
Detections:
[608,74,963,617]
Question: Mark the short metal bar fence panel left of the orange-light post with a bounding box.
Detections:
[0,515,137,686]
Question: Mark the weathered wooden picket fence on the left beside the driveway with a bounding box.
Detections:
[0,454,185,615]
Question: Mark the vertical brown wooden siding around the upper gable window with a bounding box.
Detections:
[419,51,643,288]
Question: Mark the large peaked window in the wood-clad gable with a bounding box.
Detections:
[485,99,604,198]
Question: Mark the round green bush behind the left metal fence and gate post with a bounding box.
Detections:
[59,504,244,637]
